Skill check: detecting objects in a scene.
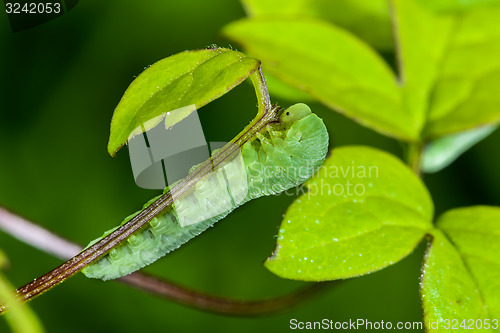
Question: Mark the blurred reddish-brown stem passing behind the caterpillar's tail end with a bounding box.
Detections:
[0,207,333,316]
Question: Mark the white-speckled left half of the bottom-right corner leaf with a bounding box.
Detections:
[420,230,491,332]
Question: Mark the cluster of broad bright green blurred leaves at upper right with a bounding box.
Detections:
[224,0,500,142]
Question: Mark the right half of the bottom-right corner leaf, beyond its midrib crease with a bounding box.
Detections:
[437,206,500,319]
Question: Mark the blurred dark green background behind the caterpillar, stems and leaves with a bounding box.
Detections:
[0,0,500,333]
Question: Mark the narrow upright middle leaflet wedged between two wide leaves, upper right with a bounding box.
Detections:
[391,0,453,135]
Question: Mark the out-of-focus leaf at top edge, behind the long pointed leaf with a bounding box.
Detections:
[242,0,394,51]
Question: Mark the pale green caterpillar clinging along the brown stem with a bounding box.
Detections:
[82,104,328,280]
